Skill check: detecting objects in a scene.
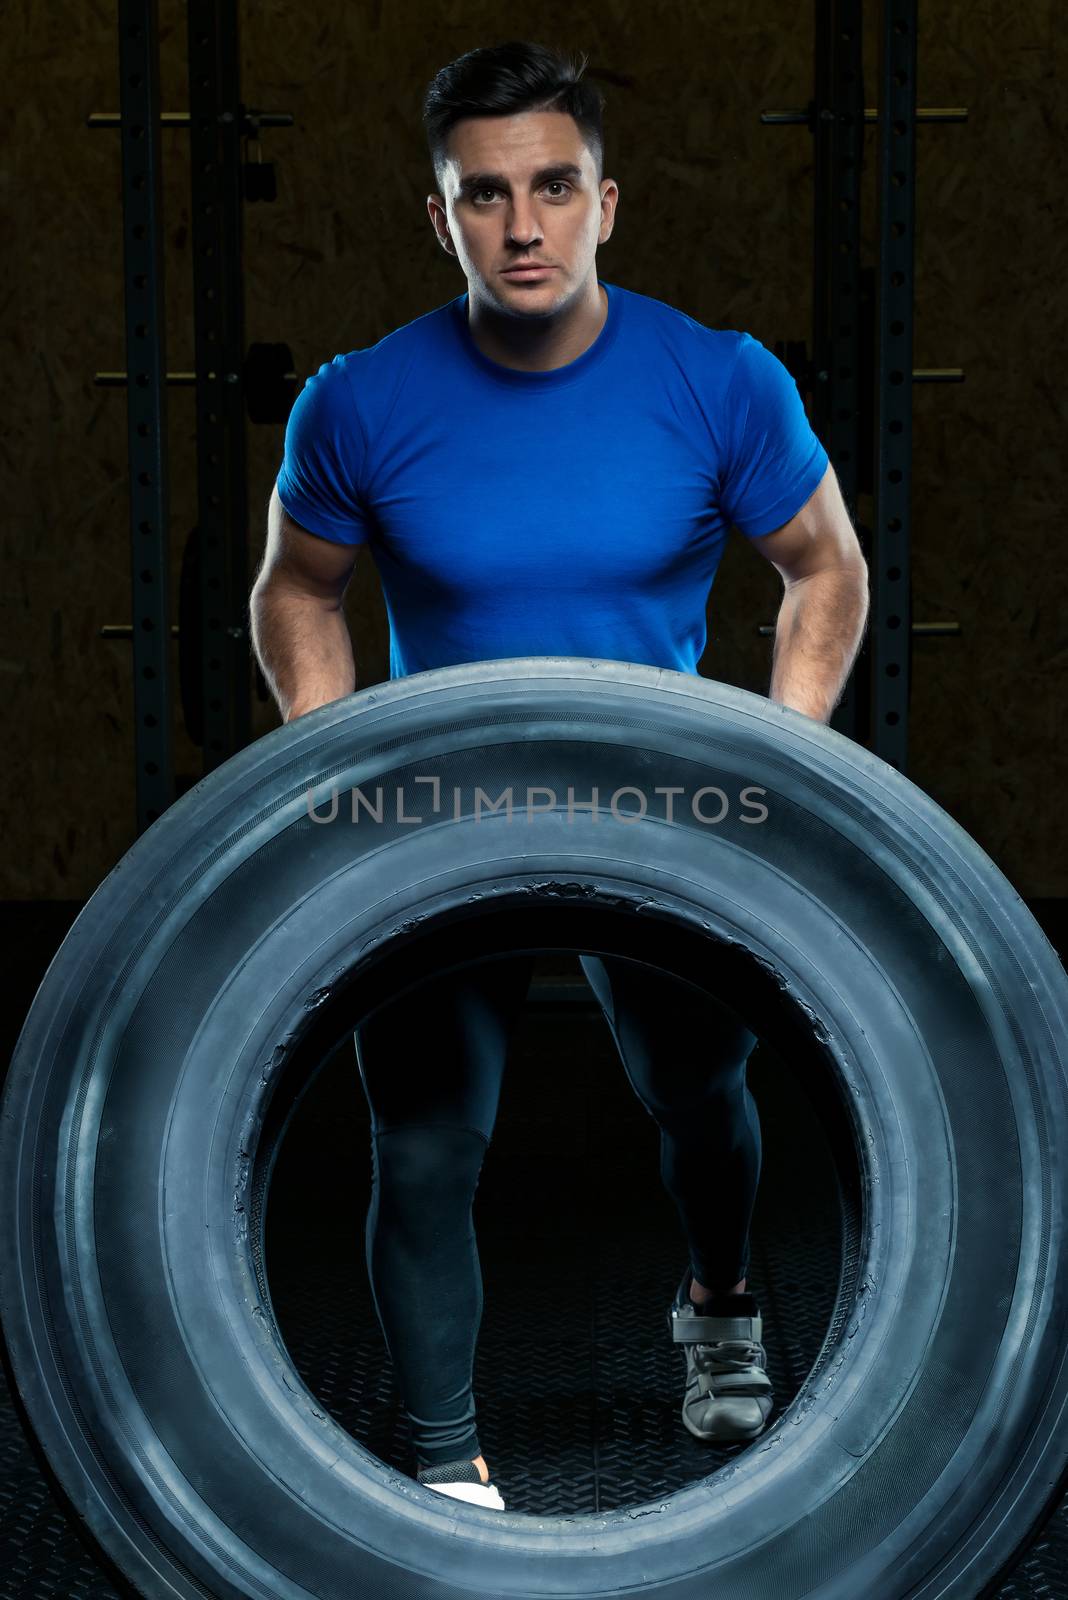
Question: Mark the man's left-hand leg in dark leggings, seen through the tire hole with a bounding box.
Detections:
[355,957,532,1482]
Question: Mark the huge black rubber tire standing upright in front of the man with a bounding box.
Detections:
[0,658,1068,1600]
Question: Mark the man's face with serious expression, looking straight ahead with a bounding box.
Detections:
[427,110,619,317]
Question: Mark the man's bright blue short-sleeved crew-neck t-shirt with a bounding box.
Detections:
[278,283,828,678]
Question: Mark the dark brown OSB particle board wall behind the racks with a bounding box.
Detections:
[0,0,1068,899]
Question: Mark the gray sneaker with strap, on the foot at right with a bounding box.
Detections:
[668,1269,775,1443]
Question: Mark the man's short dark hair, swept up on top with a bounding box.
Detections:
[422,40,604,192]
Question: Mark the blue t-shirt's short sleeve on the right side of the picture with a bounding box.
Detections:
[719,333,830,538]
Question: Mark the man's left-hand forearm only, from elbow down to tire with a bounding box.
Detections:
[249,584,357,722]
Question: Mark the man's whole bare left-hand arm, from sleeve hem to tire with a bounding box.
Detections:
[249,486,358,722]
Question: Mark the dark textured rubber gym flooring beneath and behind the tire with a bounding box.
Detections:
[0,901,1068,1600]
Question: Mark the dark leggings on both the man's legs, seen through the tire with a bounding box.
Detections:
[355,955,761,1467]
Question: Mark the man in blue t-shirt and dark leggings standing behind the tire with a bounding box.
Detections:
[251,43,868,1506]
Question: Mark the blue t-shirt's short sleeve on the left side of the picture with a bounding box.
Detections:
[278,355,369,544]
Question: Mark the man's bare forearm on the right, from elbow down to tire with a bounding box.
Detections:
[767,563,868,722]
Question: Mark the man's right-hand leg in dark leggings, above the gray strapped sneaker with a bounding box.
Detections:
[580,955,761,1304]
